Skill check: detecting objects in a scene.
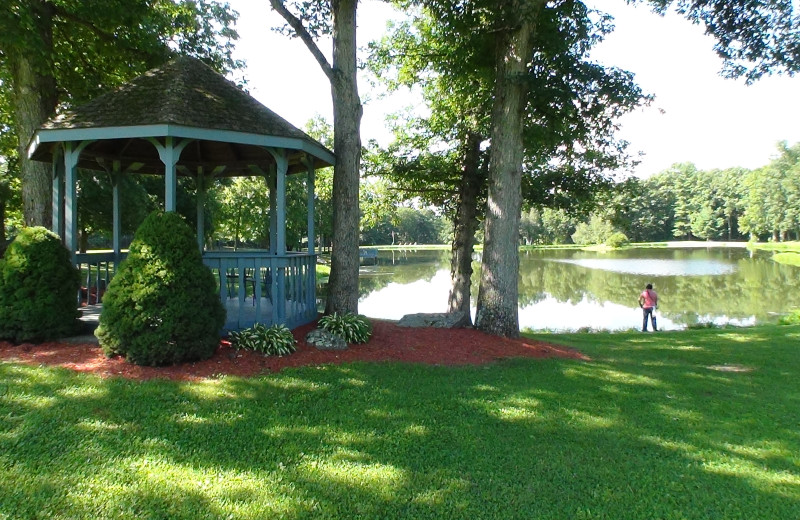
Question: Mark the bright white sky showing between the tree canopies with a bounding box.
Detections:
[225,0,800,177]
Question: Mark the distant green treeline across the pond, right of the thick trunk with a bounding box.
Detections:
[520,143,800,244]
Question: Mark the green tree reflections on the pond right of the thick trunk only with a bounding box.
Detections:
[520,249,800,324]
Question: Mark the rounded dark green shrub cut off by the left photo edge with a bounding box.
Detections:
[0,226,80,342]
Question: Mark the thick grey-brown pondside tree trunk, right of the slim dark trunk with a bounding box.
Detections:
[475,6,541,337]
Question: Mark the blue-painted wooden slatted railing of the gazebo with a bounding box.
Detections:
[75,251,317,330]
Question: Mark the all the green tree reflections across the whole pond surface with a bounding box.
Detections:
[359,248,800,325]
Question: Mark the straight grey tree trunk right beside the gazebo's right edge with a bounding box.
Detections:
[325,0,362,314]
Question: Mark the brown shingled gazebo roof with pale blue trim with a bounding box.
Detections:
[30,56,334,176]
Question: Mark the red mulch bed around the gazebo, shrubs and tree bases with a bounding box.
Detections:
[0,320,588,381]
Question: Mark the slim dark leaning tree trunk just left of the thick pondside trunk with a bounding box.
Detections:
[447,134,482,325]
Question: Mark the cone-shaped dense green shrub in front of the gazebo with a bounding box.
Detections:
[95,211,225,366]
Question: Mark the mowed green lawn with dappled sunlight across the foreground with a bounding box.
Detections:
[0,326,800,519]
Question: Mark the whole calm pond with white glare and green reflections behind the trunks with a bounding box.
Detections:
[359,247,800,332]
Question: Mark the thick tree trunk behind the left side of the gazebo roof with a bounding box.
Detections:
[7,1,58,229]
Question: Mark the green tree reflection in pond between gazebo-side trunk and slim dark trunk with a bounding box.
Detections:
[358,249,450,298]
